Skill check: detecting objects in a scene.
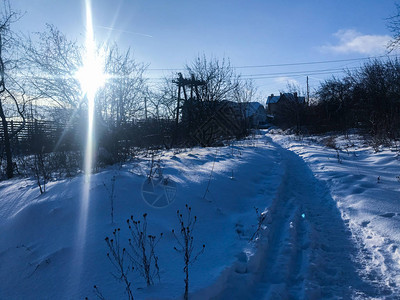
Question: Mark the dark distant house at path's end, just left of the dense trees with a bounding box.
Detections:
[266,93,306,119]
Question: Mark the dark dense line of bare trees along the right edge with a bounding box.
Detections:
[272,58,400,139]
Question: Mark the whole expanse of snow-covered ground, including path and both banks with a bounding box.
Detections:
[0,131,400,299]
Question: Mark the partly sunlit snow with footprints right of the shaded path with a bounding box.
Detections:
[274,135,400,297]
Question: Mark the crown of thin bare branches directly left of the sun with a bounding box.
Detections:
[23,24,83,112]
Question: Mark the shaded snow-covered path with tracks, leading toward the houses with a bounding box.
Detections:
[205,140,382,299]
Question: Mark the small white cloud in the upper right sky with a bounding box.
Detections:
[321,29,391,55]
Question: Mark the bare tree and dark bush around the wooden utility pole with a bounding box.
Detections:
[156,55,255,146]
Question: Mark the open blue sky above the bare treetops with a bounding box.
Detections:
[12,0,395,97]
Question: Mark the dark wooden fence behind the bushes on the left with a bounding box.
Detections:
[0,119,182,158]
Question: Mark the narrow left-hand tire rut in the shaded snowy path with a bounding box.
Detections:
[252,152,304,299]
